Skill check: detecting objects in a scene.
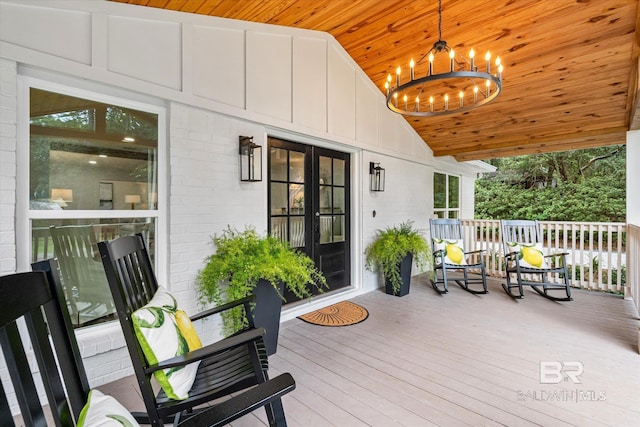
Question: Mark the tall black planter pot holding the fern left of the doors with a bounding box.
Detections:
[253,279,284,356]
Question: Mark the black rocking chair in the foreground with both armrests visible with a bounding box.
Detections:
[98,234,295,426]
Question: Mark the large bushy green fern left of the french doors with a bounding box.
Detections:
[196,226,327,335]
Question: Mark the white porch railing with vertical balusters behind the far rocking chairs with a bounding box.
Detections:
[461,220,626,292]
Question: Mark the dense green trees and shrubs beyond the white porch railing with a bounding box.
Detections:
[475,146,626,222]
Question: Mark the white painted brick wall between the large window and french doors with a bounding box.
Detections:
[169,103,267,342]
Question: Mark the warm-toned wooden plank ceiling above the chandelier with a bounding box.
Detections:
[113,0,640,161]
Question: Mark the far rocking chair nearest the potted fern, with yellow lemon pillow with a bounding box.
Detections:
[429,219,488,294]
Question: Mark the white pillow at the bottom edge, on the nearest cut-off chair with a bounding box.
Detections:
[78,390,139,427]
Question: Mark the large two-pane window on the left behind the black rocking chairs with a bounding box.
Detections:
[28,87,160,327]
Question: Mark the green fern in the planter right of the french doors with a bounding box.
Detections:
[364,221,433,292]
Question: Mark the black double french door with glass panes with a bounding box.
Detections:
[268,138,351,302]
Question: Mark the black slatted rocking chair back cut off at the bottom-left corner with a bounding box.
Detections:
[0,259,89,426]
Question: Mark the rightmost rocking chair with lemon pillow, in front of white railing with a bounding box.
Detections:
[500,220,573,301]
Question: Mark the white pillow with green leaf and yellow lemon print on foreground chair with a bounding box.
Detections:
[131,287,202,400]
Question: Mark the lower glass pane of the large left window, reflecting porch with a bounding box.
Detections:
[31,218,155,327]
